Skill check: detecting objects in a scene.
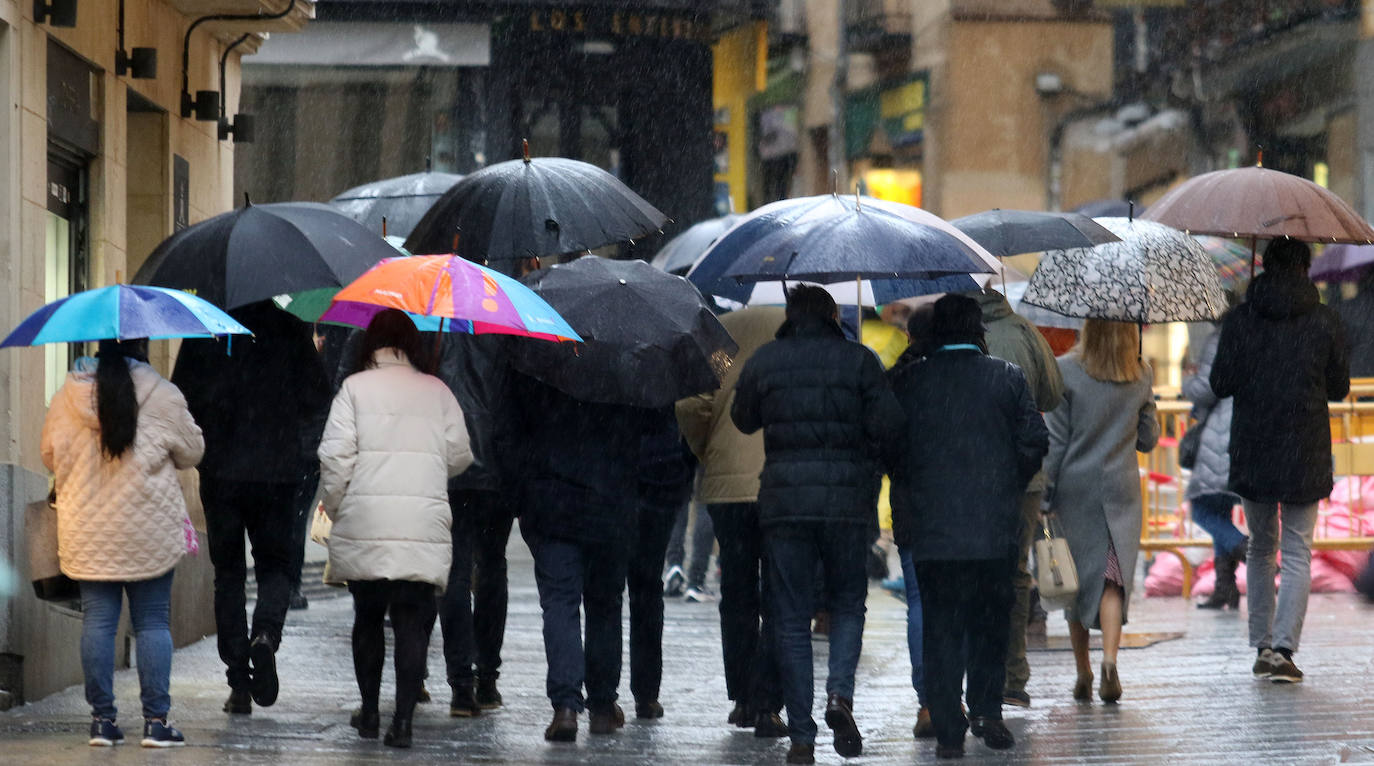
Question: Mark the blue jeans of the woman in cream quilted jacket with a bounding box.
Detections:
[81,572,172,721]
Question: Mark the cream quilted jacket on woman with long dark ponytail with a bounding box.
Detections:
[43,360,205,580]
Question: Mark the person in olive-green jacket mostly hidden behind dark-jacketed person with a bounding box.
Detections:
[970,289,1063,707]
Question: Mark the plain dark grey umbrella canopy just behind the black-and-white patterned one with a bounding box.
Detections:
[949,209,1120,257]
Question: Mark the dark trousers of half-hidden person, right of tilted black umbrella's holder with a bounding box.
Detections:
[625,502,675,703]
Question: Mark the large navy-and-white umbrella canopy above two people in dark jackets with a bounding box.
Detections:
[687,194,999,303]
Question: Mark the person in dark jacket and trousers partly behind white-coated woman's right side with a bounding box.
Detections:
[422,333,518,718]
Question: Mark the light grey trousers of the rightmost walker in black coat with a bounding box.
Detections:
[1243,501,1316,652]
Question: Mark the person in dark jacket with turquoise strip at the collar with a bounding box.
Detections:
[890,296,1050,758]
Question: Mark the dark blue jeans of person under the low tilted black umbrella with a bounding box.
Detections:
[521,525,628,712]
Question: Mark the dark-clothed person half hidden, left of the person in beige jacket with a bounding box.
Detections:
[627,406,697,718]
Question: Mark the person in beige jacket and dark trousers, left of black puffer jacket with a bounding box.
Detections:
[677,307,787,737]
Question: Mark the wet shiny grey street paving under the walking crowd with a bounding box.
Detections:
[0,539,1374,766]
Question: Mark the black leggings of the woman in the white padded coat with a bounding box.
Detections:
[348,580,434,719]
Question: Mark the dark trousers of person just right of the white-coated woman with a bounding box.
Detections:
[438,490,514,685]
